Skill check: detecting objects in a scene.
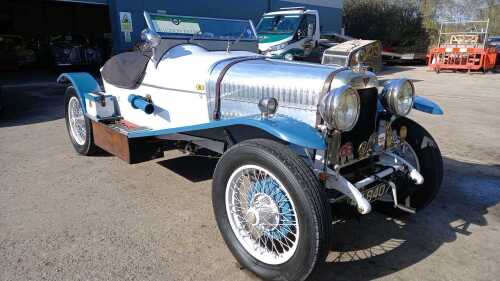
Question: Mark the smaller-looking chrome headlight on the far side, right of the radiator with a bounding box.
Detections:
[382,79,415,116]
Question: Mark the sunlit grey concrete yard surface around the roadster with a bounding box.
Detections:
[0,67,500,281]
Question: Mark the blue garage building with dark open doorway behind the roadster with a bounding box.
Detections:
[0,0,342,60]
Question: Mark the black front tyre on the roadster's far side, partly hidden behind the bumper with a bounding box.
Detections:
[374,118,443,217]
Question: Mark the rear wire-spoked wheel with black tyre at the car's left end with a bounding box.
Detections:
[64,86,97,155]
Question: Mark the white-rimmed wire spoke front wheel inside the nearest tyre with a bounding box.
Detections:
[225,165,299,265]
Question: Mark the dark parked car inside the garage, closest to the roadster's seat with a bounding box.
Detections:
[49,34,103,66]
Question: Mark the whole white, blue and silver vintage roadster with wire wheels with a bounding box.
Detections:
[59,12,443,280]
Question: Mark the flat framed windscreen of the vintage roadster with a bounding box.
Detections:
[144,13,257,40]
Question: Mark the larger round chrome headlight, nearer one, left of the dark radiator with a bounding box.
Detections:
[319,85,360,132]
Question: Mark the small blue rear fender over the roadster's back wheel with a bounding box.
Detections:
[57,72,101,113]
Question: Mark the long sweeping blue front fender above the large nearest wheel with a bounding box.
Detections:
[127,115,326,150]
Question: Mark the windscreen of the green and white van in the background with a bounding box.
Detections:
[257,15,301,34]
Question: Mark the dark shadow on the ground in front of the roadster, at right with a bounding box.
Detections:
[313,159,500,281]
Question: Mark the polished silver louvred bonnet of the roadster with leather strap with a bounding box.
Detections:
[207,57,376,126]
